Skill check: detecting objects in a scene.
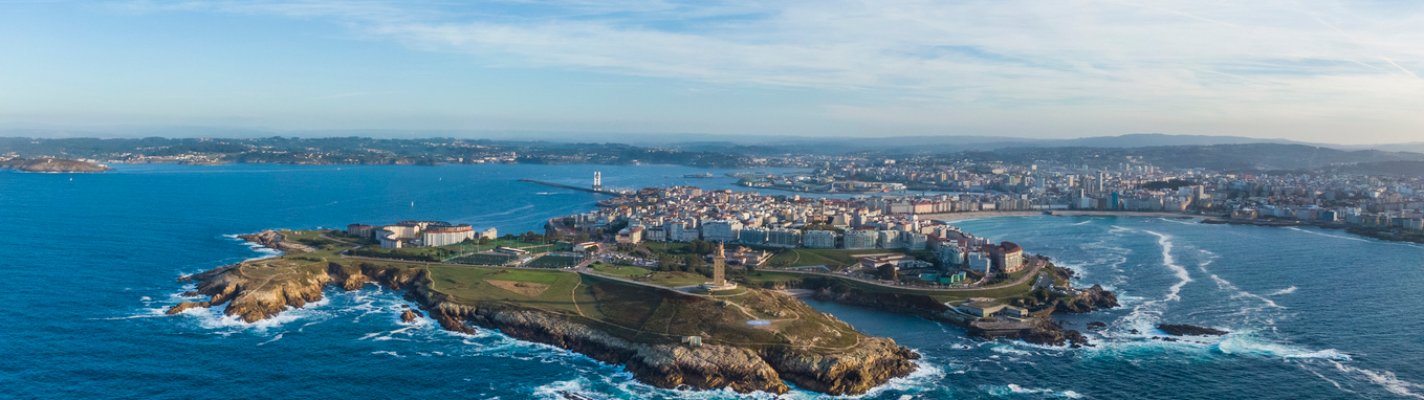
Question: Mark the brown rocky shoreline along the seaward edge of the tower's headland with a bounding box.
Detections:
[168,232,918,394]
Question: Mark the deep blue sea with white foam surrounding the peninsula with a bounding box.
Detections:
[0,165,1424,399]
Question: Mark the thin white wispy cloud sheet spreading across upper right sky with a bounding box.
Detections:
[105,0,1424,140]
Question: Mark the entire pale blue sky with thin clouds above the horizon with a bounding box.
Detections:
[0,0,1424,144]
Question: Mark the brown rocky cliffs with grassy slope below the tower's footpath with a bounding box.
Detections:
[169,233,918,394]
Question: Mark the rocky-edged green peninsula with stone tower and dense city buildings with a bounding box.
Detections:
[168,186,1118,394]
